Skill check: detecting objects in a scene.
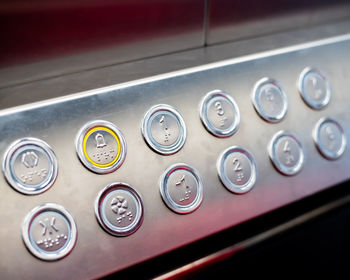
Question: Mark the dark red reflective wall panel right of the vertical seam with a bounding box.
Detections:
[206,0,350,45]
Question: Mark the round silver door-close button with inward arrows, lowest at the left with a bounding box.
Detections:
[22,203,77,261]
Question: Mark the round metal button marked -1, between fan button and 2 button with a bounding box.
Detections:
[160,163,203,214]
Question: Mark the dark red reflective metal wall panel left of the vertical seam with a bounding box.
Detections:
[0,0,204,87]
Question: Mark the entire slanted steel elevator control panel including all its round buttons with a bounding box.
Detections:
[0,36,350,279]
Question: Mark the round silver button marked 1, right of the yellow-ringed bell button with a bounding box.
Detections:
[141,105,186,155]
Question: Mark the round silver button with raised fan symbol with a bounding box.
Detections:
[95,182,144,236]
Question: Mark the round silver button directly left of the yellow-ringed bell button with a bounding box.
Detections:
[3,138,58,194]
